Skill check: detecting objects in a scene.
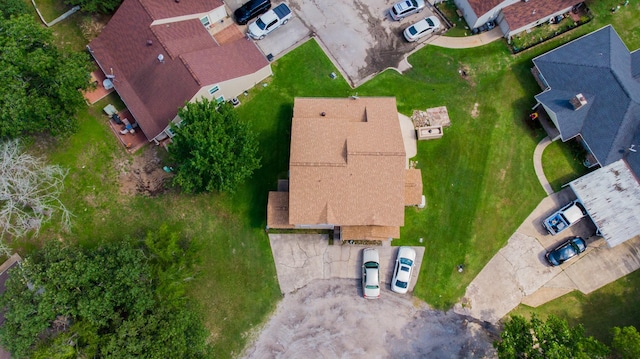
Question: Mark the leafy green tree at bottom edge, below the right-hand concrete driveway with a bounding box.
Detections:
[493,315,609,359]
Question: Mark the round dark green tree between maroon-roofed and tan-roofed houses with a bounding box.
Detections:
[169,99,260,193]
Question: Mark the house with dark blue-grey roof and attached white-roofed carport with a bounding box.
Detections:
[532,25,640,247]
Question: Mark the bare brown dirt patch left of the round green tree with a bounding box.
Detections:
[117,146,172,196]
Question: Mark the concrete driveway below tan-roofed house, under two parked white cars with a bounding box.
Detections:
[269,234,424,294]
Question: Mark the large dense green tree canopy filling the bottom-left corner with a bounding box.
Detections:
[0,227,208,358]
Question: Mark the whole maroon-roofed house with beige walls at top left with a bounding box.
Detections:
[87,0,272,143]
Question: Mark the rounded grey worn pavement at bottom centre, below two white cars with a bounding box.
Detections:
[243,279,497,358]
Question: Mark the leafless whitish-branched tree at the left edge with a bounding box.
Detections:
[0,140,71,246]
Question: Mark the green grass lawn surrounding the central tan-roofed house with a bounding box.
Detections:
[17,0,640,357]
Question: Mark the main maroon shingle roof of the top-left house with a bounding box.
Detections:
[89,0,269,140]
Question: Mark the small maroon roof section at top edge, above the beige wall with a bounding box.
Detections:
[139,0,223,20]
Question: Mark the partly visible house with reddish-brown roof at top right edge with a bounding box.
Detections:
[454,0,583,39]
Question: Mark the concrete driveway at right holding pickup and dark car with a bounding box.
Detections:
[454,188,640,323]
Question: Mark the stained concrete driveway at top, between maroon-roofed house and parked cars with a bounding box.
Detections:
[225,0,444,87]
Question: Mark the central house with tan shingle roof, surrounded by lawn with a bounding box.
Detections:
[267,97,422,240]
